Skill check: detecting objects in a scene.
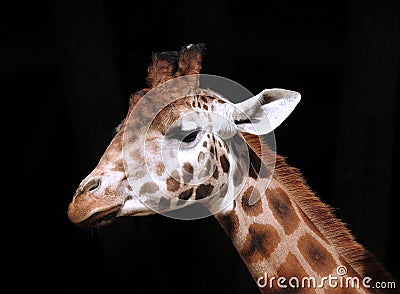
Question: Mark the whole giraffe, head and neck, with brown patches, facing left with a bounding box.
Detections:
[68,44,397,293]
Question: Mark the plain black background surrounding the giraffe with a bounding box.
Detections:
[10,0,400,293]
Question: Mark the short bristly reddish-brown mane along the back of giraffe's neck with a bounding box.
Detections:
[242,132,394,288]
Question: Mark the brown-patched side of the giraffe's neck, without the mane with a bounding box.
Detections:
[216,180,360,292]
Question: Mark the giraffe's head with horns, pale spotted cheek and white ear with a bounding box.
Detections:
[68,44,300,225]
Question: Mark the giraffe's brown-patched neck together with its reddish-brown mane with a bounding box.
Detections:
[215,135,393,293]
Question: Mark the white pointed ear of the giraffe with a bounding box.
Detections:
[232,89,301,135]
